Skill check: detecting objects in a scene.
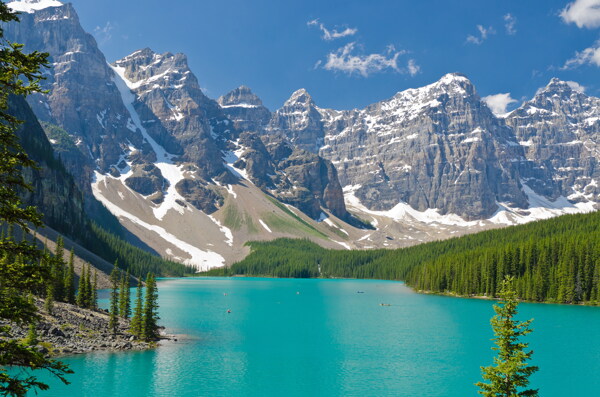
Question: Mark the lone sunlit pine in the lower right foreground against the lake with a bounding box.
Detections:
[476,276,538,397]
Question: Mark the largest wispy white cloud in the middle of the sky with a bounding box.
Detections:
[323,42,412,77]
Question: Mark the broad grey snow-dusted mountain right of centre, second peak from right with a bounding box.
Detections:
[320,74,527,219]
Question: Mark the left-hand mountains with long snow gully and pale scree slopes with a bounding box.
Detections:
[5,1,358,268]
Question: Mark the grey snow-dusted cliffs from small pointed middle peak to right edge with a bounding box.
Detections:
[230,73,599,220]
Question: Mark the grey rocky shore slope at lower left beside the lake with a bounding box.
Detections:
[0,300,175,357]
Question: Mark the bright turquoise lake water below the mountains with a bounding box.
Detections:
[25,278,600,397]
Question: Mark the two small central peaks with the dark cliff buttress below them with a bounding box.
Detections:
[219,86,351,220]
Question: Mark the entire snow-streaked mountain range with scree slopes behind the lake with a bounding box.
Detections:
[5,0,600,268]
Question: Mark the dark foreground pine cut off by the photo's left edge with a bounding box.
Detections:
[0,2,72,395]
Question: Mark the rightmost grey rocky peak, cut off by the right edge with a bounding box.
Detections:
[506,79,600,202]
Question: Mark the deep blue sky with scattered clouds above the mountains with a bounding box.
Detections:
[65,0,600,110]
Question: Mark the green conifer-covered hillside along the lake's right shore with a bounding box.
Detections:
[213,212,600,304]
